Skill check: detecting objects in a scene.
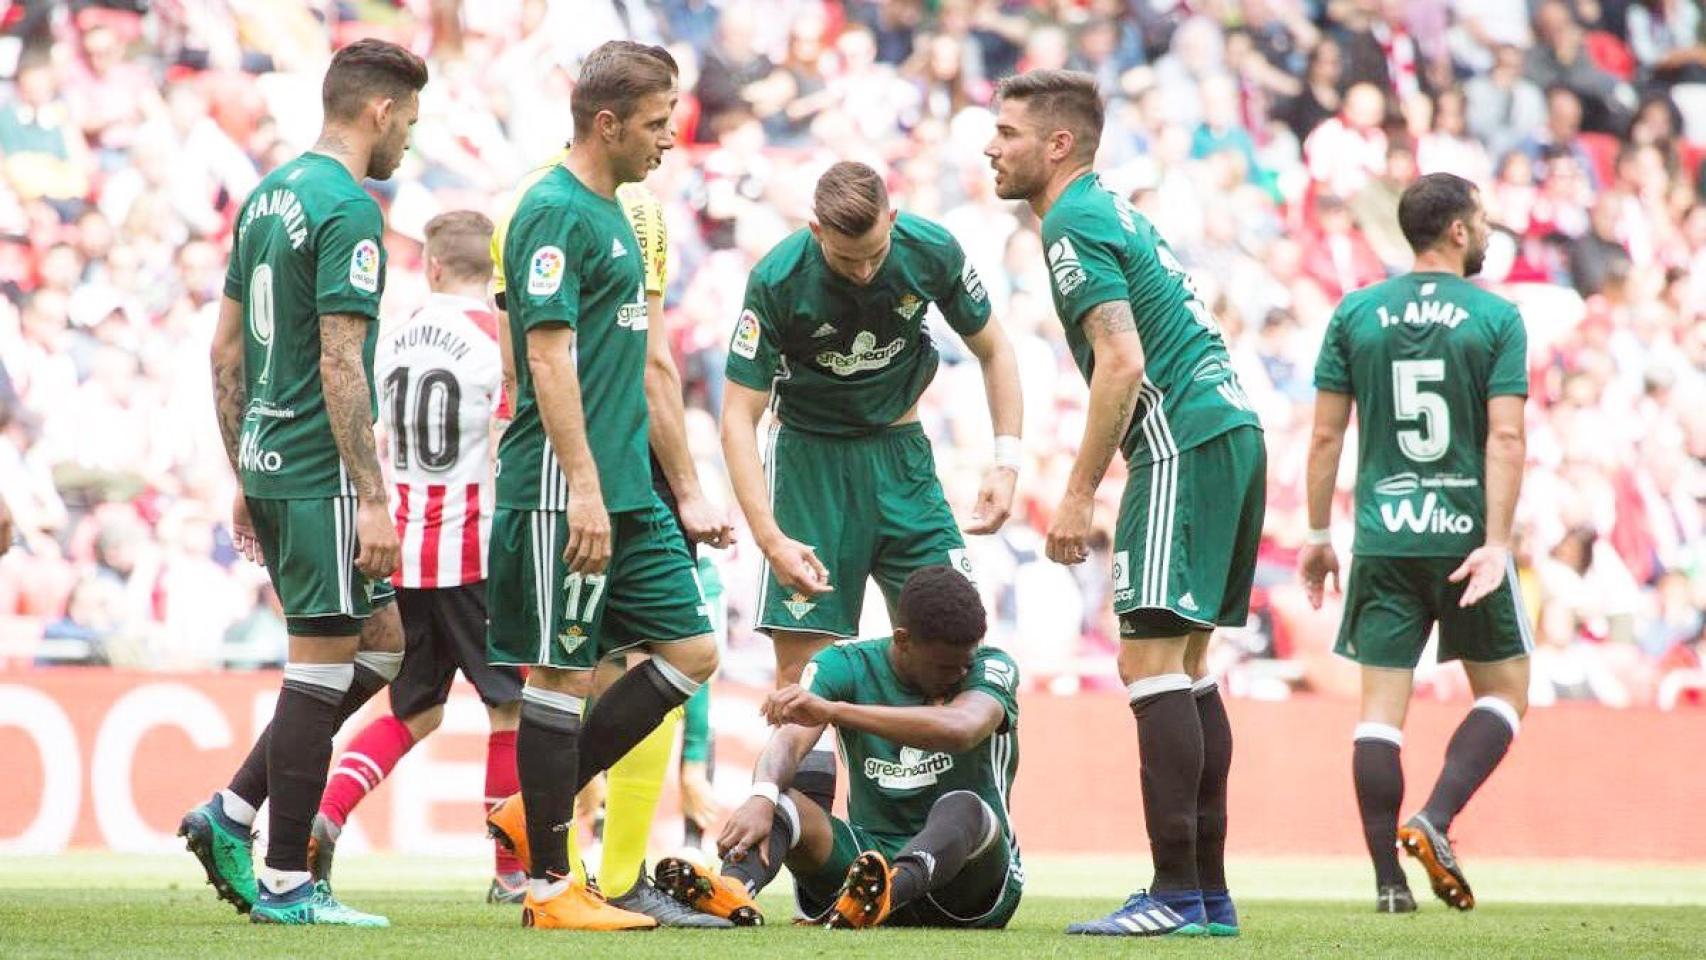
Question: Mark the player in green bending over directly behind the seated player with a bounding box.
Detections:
[722,162,1022,810]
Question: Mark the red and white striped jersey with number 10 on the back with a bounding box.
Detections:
[374,293,503,588]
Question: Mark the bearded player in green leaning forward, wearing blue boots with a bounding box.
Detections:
[984,70,1268,936]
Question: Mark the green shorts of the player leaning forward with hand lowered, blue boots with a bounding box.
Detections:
[1114,426,1268,639]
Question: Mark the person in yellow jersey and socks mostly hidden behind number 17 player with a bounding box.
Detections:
[488,148,732,928]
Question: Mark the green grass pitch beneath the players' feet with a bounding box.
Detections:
[0,854,1706,960]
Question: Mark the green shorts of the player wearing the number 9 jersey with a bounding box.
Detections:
[244,496,396,636]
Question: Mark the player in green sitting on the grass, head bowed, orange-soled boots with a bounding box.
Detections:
[657,566,1025,928]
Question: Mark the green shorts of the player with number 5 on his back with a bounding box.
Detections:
[1332,556,1534,670]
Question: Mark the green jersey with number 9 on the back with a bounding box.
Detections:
[225,153,386,500]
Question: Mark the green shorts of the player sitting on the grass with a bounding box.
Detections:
[793,817,1025,929]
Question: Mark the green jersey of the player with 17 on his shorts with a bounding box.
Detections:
[498,165,652,513]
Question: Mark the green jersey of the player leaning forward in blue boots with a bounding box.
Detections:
[1042,174,1261,467]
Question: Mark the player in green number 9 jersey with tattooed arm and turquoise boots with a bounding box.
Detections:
[179,39,427,926]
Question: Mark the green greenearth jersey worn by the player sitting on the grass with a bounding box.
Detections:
[800,636,1018,858]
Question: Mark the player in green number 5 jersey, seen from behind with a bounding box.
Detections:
[1298,174,1534,914]
